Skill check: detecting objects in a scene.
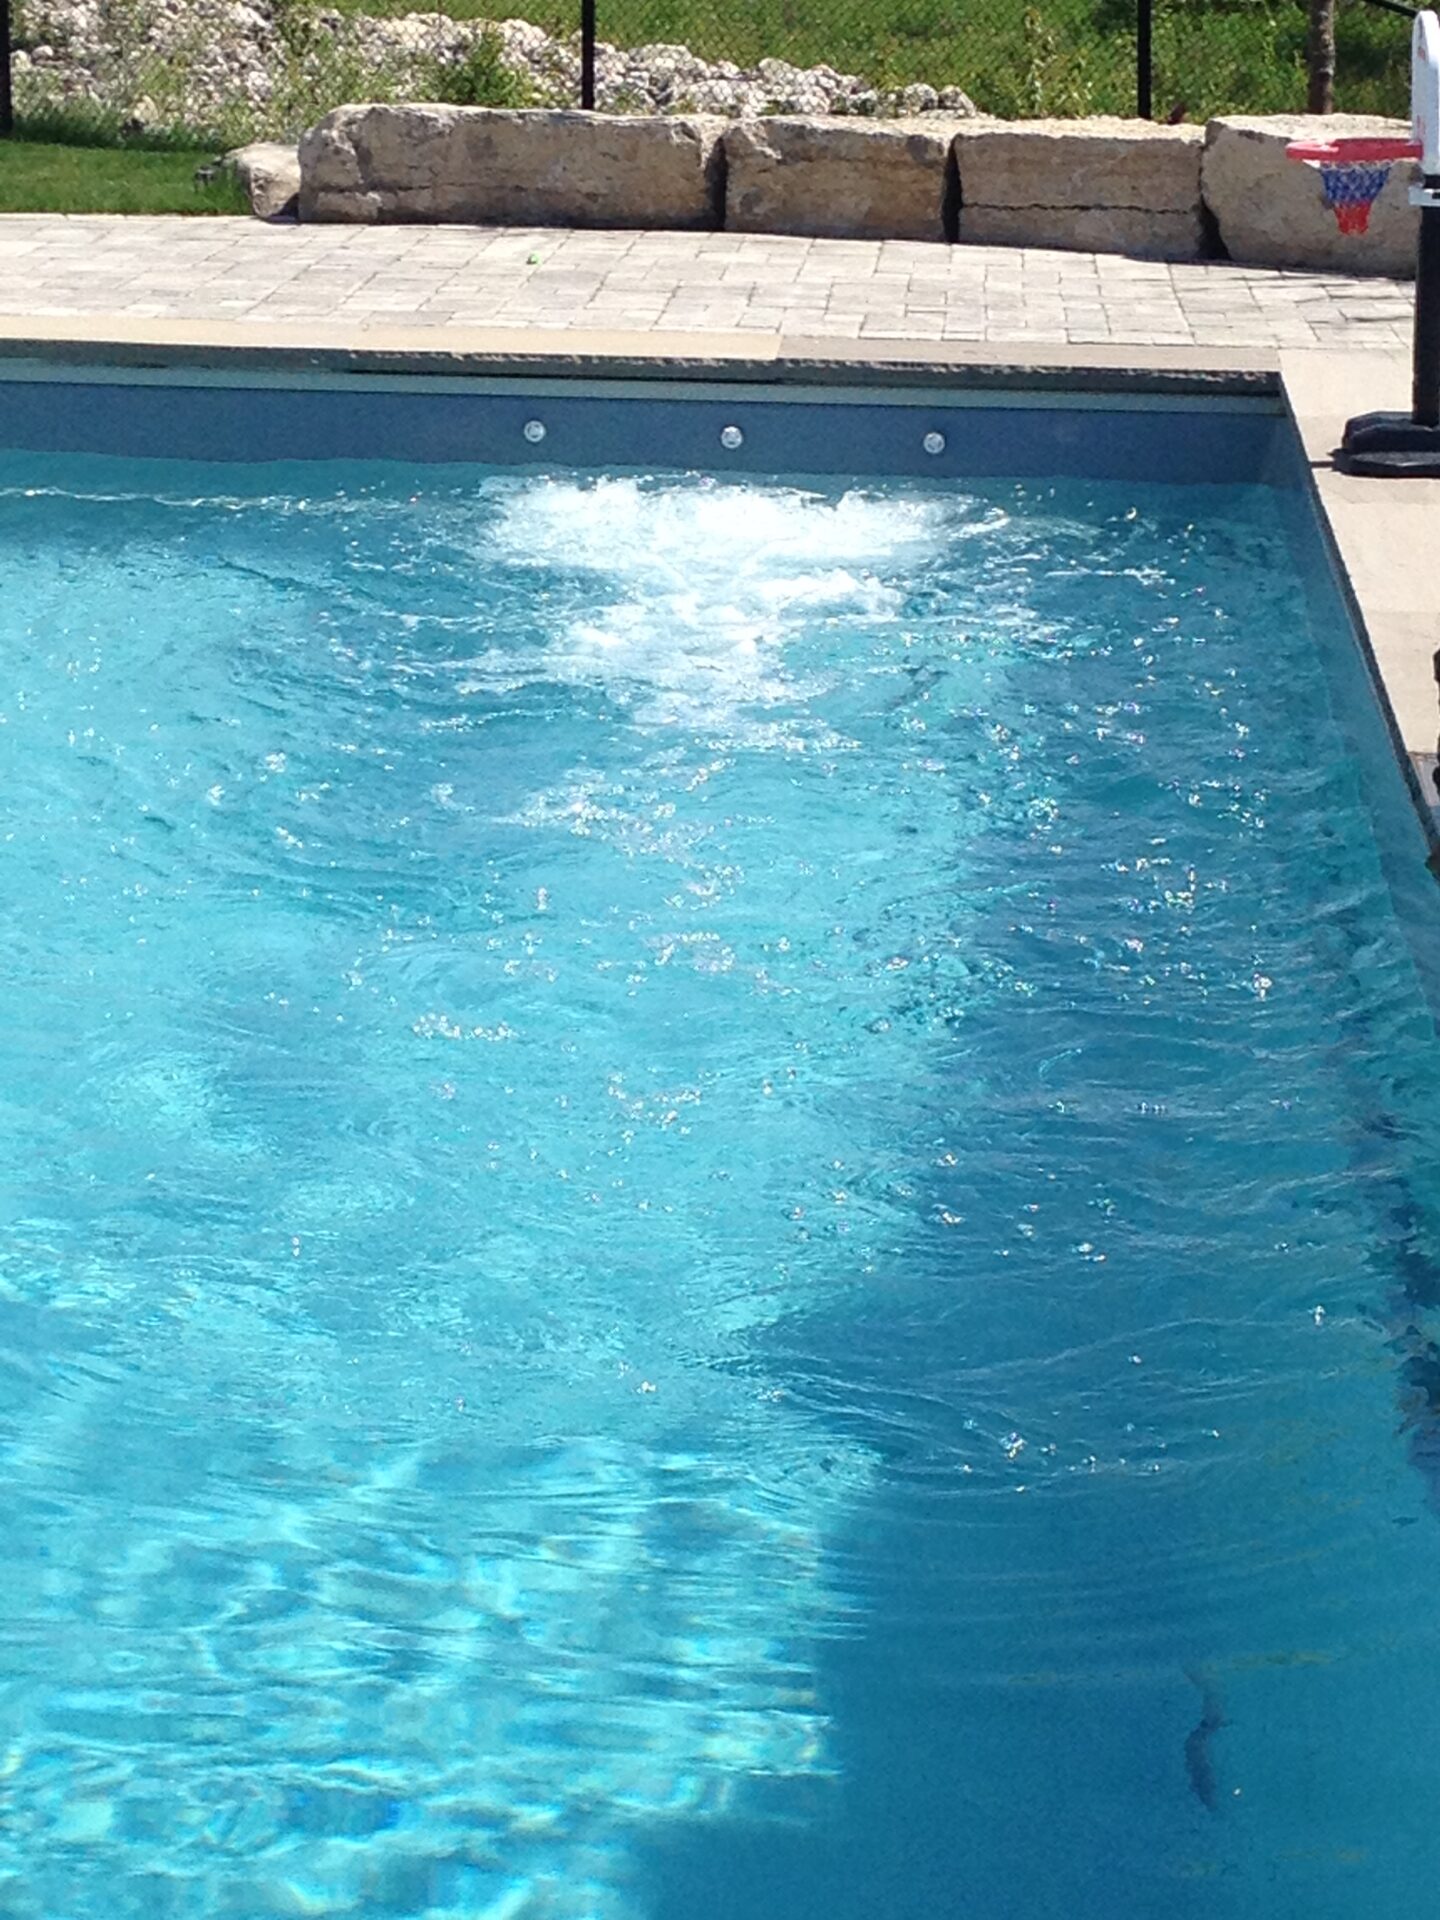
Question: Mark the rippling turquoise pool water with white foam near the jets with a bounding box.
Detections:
[0,457,1440,1920]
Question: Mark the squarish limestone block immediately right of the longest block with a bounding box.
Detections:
[726,113,975,240]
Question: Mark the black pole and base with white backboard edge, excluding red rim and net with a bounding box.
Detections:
[1338,12,1440,478]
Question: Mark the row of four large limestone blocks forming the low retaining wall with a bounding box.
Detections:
[289,106,1419,275]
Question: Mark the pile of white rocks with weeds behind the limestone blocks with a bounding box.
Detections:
[13,0,975,138]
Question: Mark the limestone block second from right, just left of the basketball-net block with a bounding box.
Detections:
[954,119,1204,259]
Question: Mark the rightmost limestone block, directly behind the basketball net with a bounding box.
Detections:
[1202,113,1419,275]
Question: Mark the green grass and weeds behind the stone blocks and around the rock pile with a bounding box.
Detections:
[0,0,1409,149]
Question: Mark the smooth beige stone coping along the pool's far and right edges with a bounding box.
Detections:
[0,317,1440,829]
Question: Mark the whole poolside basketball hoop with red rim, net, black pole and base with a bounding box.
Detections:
[1284,12,1440,476]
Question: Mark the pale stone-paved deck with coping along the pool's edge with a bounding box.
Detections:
[0,213,1440,817]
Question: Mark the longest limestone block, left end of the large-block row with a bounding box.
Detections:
[300,106,726,227]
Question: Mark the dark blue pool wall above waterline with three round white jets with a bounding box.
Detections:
[0,363,1284,484]
